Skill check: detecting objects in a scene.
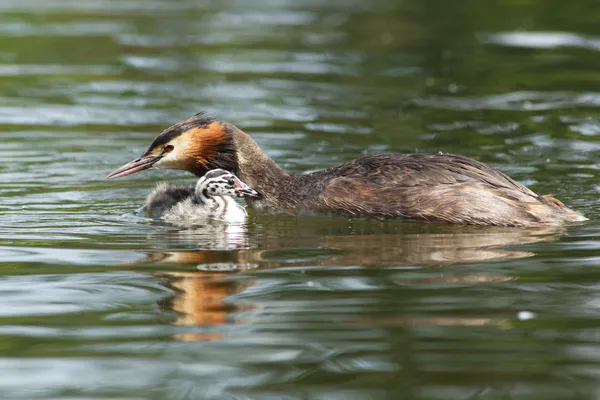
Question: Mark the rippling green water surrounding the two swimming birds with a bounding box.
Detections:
[0,0,600,400]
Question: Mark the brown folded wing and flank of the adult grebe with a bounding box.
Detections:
[320,155,552,226]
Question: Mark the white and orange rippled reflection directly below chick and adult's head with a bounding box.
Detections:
[148,224,258,341]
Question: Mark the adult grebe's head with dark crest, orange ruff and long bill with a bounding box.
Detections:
[106,113,237,179]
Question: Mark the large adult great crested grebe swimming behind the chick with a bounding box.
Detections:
[106,114,586,227]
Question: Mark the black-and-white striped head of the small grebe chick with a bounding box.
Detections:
[196,169,260,200]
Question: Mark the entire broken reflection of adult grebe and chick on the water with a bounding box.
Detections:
[139,219,562,341]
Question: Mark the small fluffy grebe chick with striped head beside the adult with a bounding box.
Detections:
[146,169,260,226]
